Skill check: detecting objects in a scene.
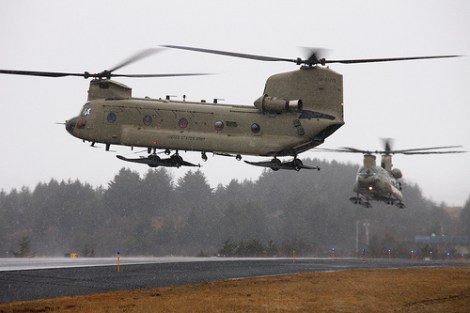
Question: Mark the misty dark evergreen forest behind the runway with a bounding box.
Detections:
[0,159,470,257]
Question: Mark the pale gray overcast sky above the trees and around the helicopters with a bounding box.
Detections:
[0,0,470,205]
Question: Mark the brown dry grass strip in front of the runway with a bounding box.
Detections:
[0,267,470,313]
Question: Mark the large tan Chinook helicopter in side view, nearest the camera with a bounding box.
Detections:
[0,46,456,171]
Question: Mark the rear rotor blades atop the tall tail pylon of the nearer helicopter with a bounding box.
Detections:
[162,45,460,66]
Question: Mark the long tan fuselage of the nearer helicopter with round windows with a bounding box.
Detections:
[69,98,337,156]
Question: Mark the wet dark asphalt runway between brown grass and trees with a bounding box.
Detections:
[0,258,468,303]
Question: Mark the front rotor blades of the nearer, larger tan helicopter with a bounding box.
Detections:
[0,48,208,79]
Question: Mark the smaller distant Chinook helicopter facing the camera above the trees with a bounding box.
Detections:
[322,139,466,209]
